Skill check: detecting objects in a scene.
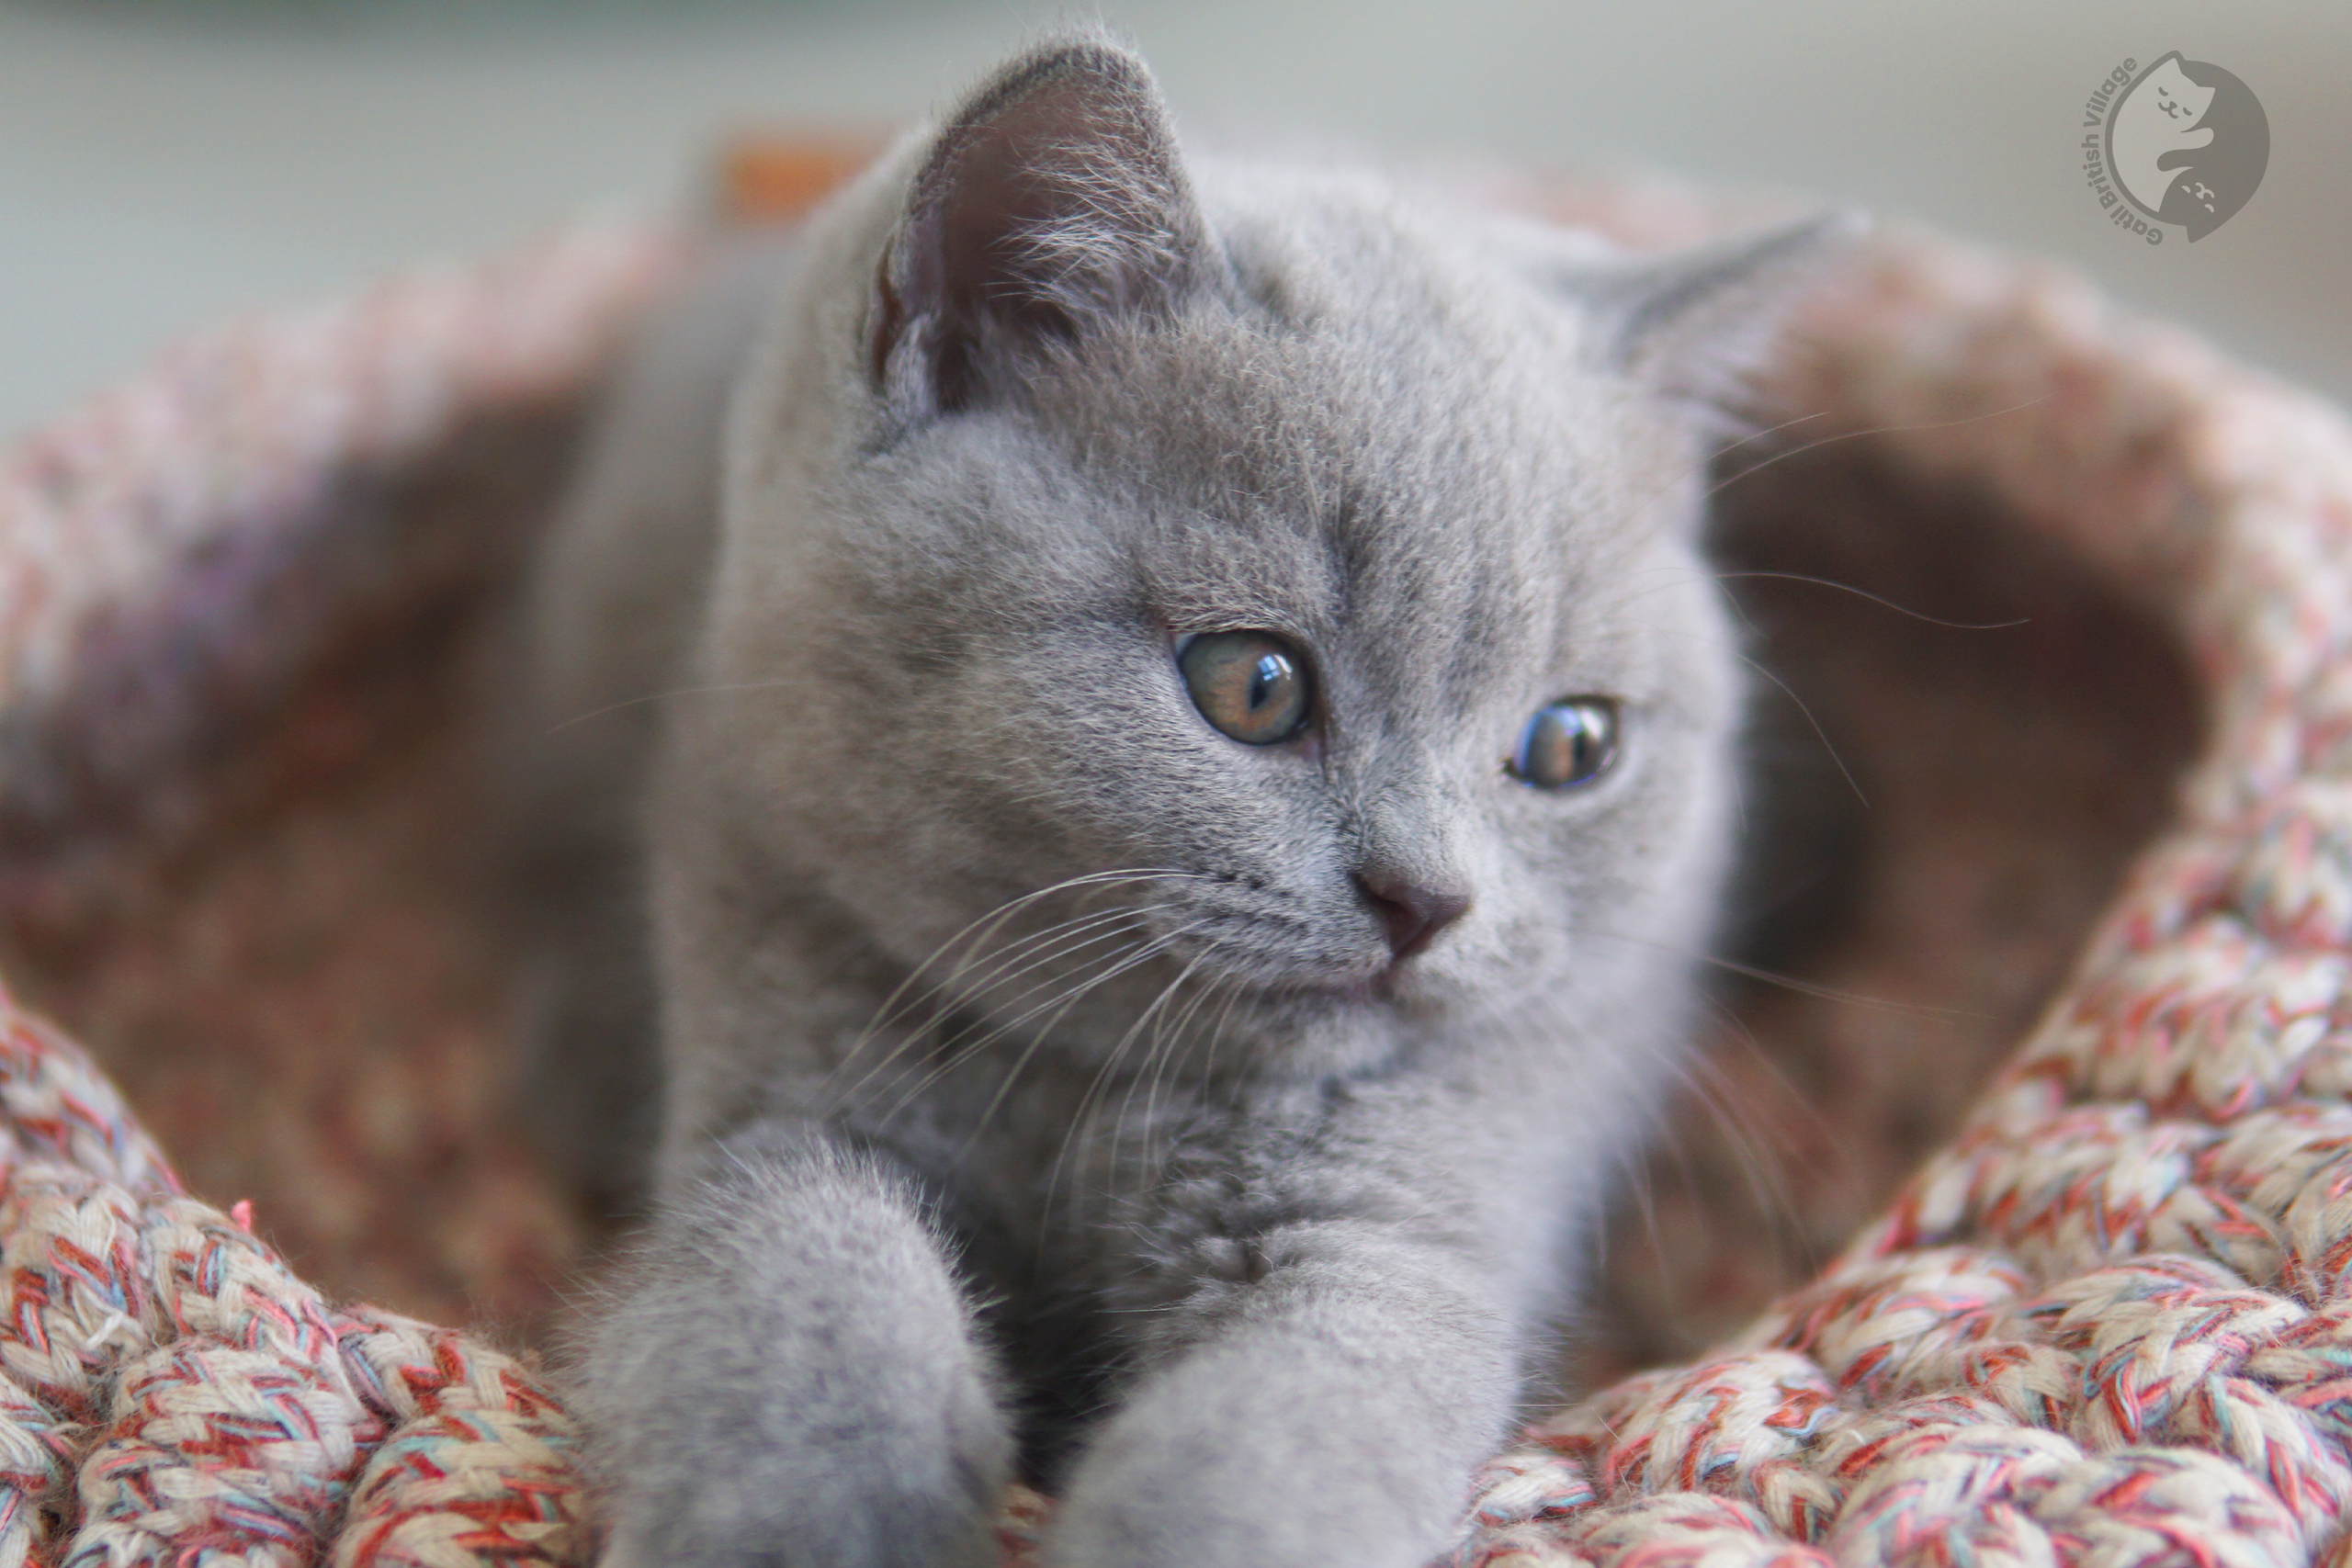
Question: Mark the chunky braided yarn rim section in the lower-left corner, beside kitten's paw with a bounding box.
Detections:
[0,997,588,1568]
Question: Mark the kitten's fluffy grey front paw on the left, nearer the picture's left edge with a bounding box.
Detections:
[583,1138,1013,1568]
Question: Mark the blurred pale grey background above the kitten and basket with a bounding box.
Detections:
[0,0,2352,437]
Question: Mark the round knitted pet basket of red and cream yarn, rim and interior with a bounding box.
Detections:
[0,162,2352,1568]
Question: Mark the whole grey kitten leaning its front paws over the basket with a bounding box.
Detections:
[538,38,1839,1568]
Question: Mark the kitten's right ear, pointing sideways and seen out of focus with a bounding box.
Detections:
[1559,211,1870,407]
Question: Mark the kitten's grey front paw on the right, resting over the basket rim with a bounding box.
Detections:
[1045,1223,1517,1568]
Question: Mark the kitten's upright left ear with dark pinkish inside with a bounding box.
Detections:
[868,38,1206,413]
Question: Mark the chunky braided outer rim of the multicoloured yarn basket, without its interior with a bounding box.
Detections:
[0,162,2352,1568]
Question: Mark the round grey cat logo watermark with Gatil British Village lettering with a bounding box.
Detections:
[2082,50,2269,244]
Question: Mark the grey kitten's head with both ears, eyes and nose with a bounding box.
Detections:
[692,40,1827,1086]
